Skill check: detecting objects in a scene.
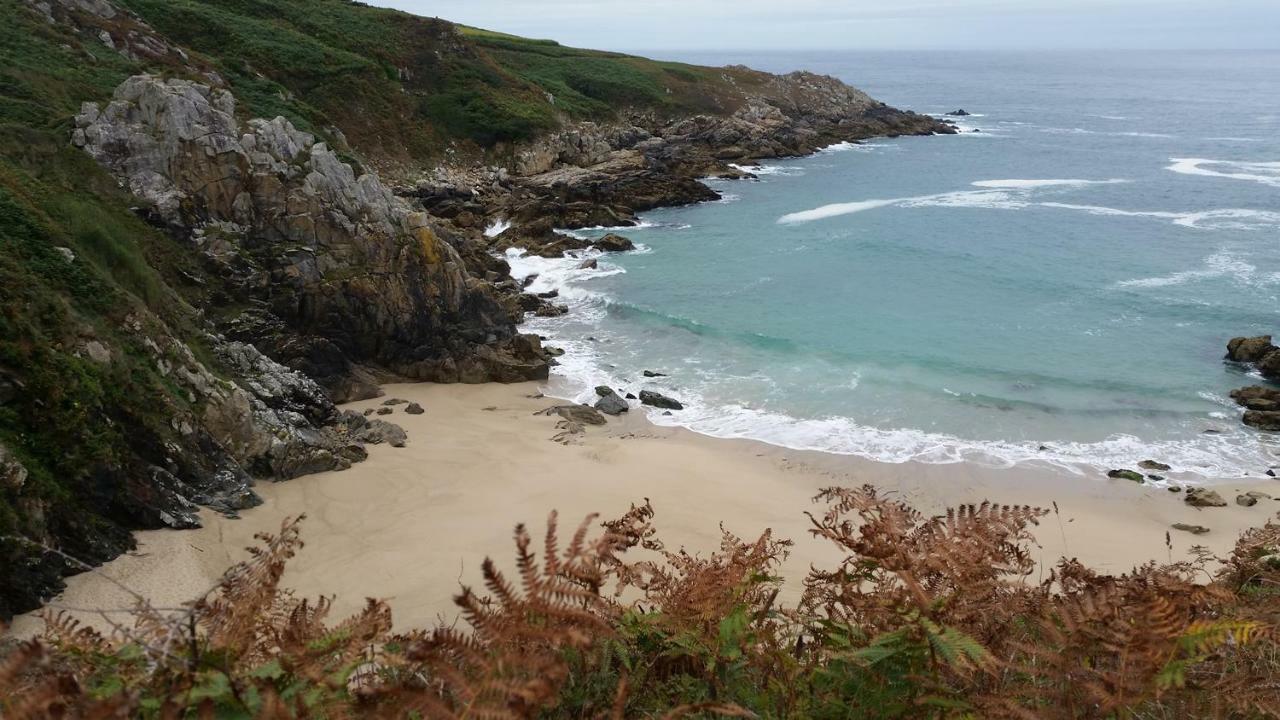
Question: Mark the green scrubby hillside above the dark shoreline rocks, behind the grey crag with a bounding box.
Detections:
[107,0,757,165]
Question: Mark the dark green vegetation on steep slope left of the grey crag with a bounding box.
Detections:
[0,0,224,616]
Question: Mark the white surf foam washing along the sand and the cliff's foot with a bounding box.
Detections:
[496,237,1271,482]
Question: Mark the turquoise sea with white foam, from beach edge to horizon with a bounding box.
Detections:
[513,53,1280,478]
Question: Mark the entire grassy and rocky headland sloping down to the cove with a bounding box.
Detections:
[0,0,948,618]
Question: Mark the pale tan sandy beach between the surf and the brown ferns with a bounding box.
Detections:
[12,383,1280,635]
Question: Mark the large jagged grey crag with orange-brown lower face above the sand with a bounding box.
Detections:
[73,76,547,392]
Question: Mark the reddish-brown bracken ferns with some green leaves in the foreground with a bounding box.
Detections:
[0,487,1280,719]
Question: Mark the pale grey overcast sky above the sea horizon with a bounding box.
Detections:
[371,0,1280,50]
